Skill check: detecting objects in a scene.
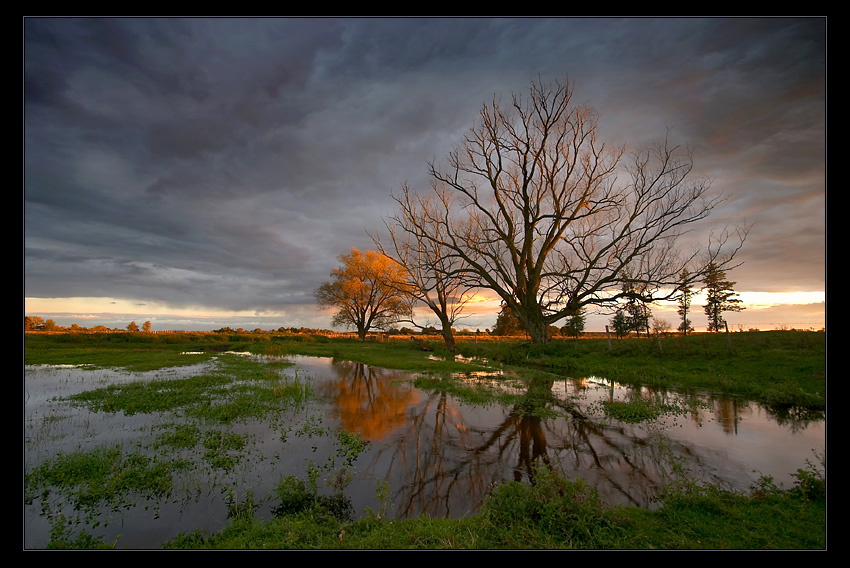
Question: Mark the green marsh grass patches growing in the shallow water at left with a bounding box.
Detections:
[24,354,314,539]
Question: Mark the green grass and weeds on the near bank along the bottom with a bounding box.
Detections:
[159,467,826,550]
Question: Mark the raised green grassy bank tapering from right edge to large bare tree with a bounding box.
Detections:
[460,331,826,409]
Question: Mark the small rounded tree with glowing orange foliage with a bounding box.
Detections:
[315,248,410,340]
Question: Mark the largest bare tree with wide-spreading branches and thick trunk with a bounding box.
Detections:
[399,75,745,343]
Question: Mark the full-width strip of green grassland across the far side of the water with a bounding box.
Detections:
[24,331,826,409]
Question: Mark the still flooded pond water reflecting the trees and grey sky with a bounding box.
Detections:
[24,357,825,548]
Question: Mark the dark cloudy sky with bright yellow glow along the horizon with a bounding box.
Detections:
[23,17,827,331]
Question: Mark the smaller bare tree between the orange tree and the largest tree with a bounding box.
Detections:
[372,184,474,352]
